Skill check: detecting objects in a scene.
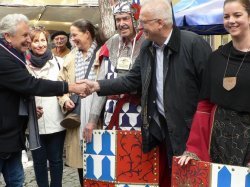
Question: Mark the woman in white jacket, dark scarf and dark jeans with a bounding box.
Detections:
[26,26,66,187]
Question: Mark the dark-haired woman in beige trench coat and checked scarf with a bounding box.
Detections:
[59,19,105,186]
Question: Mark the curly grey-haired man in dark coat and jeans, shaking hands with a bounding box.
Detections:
[0,14,86,187]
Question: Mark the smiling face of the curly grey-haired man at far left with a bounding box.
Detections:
[4,22,31,53]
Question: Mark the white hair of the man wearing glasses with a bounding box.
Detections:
[142,0,173,25]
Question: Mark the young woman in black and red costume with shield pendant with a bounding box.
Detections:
[179,0,250,166]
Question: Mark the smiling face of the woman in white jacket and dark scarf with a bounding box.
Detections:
[31,32,48,56]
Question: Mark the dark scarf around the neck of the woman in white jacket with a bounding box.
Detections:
[26,49,53,68]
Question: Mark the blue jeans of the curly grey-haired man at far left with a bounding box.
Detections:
[0,151,24,187]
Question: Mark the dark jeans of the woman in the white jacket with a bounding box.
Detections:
[31,131,66,187]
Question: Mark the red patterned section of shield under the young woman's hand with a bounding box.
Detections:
[172,157,210,187]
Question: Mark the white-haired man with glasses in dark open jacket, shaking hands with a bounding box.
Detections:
[81,0,211,187]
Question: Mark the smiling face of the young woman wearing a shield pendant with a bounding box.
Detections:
[224,1,250,38]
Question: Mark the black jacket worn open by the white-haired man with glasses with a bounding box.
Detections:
[99,27,211,155]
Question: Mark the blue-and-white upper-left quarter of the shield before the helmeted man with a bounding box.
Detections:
[83,130,116,182]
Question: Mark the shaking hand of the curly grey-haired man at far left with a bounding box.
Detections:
[69,82,91,97]
